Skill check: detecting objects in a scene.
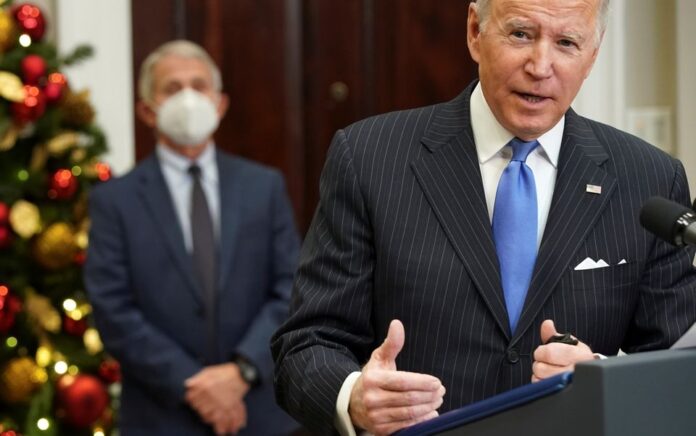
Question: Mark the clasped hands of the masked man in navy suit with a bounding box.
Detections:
[185,363,249,435]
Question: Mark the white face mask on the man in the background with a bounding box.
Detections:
[157,88,220,147]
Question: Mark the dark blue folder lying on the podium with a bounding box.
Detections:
[394,372,573,436]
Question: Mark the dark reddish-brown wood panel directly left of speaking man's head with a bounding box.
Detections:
[374,0,477,112]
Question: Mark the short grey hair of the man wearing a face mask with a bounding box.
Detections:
[138,39,222,103]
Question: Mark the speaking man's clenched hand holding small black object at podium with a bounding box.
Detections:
[532,319,595,382]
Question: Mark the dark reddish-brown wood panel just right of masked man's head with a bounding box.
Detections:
[202,0,305,222]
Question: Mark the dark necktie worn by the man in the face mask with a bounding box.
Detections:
[189,165,217,359]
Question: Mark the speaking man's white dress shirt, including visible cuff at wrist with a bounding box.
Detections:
[334,83,565,436]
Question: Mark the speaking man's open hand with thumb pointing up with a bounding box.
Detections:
[348,320,445,435]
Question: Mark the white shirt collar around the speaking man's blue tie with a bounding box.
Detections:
[470,83,565,168]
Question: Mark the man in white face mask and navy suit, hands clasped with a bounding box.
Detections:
[85,41,299,436]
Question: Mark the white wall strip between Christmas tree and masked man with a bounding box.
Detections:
[54,0,135,175]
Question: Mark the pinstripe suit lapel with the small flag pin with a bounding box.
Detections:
[513,110,616,343]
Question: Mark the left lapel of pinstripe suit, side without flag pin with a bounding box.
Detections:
[411,84,510,338]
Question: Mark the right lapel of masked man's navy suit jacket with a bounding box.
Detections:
[217,151,243,289]
